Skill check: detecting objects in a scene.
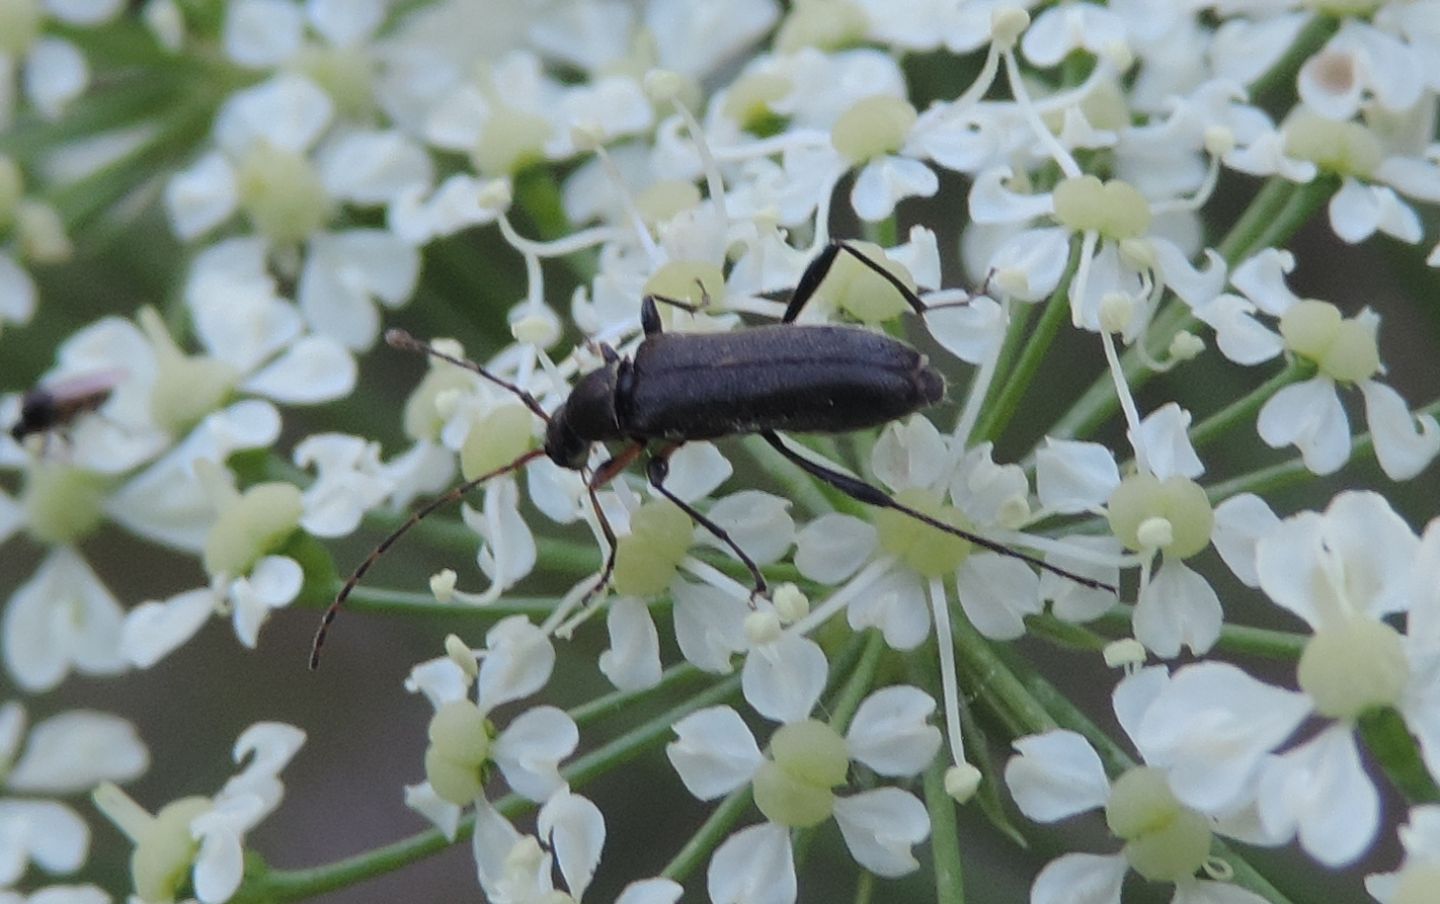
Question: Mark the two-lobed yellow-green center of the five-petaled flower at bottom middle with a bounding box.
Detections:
[753,718,850,828]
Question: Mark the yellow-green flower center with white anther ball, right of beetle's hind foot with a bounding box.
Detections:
[1107,474,1215,559]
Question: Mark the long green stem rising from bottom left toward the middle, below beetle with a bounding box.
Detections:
[253,675,740,904]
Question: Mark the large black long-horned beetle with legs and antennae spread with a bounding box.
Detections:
[310,242,1113,668]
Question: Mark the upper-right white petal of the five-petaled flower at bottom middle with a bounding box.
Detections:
[845,685,940,776]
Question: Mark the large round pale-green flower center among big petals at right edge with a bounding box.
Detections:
[1297,616,1410,718]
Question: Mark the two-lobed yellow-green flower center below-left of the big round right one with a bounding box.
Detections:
[1104,767,1211,882]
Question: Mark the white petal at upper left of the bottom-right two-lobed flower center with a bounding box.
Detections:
[1005,730,1110,822]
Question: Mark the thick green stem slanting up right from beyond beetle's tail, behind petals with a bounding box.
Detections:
[1050,177,1338,439]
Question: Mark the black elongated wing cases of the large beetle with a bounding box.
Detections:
[618,324,945,439]
